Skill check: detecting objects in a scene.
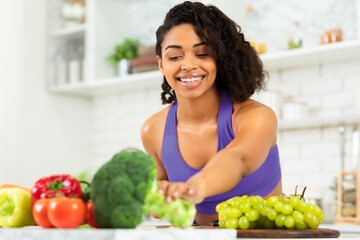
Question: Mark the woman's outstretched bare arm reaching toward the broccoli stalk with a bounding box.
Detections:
[164,101,277,203]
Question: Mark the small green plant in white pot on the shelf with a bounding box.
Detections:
[108,38,140,76]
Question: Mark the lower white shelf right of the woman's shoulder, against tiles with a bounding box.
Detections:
[278,113,360,131]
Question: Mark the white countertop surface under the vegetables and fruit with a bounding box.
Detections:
[0,220,360,240]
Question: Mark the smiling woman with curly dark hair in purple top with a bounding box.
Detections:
[141,1,282,224]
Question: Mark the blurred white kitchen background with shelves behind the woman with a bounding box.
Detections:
[0,0,360,225]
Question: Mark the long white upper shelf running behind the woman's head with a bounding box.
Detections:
[50,40,360,97]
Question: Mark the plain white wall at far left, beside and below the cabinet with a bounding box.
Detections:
[0,0,91,187]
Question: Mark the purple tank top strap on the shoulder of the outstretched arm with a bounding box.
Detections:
[217,91,235,151]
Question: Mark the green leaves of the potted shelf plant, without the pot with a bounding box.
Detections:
[108,38,140,67]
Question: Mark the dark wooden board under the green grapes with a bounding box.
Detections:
[191,226,340,238]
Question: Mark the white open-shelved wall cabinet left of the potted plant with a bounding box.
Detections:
[48,0,136,89]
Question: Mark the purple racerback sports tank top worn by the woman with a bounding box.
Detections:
[161,91,281,214]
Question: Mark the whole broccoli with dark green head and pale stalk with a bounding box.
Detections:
[91,149,196,228]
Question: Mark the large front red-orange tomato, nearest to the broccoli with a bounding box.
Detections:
[47,197,86,228]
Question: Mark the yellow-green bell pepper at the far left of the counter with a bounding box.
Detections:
[0,187,35,228]
